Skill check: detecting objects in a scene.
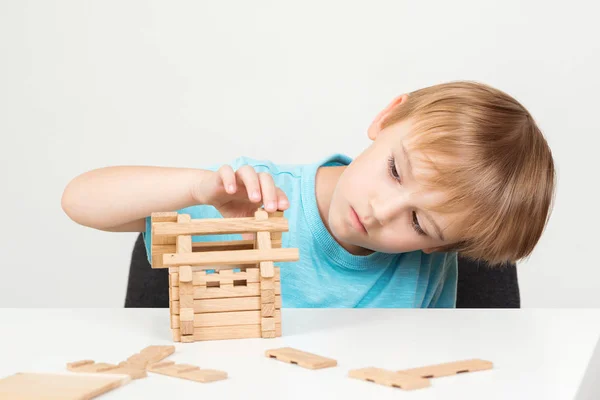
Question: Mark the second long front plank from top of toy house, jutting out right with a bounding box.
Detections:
[162,248,299,268]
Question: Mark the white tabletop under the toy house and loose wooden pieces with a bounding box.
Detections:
[0,309,600,400]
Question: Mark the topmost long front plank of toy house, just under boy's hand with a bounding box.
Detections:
[152,217,288,236]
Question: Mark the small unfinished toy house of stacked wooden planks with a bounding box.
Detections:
[151,209,299,343]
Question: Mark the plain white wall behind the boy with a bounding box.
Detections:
[0,0,600,307]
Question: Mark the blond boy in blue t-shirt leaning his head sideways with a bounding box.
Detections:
[62,81,555,307]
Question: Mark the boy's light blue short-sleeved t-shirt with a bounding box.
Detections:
[144,154,458,308]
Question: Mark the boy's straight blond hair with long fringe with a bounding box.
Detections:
[381,81,556,266]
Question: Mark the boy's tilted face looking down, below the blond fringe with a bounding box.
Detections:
[328,117,458,254]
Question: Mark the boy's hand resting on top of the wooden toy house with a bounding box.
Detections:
[191,165,289,218]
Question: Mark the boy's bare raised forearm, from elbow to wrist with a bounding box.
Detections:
[62,166,211,229]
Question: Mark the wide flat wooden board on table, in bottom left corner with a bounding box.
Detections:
[0,373,131,400]
